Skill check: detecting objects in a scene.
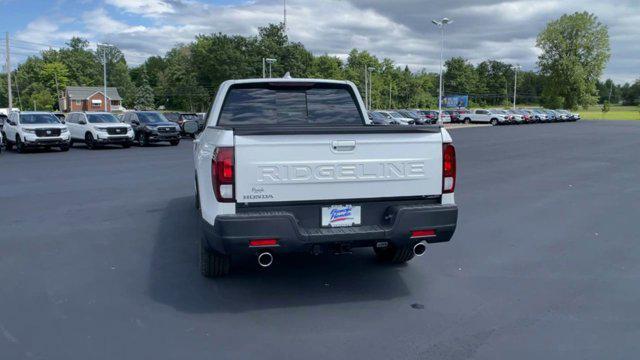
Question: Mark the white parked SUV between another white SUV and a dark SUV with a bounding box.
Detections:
[66,112,133,149]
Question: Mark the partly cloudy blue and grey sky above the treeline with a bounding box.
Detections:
[0,0,640,83]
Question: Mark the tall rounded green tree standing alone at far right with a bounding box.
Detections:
[536,12,611,109]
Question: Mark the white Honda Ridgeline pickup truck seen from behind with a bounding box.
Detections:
[194,78,458,277]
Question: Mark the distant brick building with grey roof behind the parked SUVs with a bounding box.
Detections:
[60,86,124,112]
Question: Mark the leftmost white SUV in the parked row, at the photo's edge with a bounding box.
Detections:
[2,111,70,152]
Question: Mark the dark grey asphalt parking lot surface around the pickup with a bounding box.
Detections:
[0,121,640,359]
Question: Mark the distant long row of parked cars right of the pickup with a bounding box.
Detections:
[369,108,580,125]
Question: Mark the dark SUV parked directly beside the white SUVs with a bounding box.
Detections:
[122,111,180,146]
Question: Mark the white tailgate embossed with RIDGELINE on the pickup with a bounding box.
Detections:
[234,131,442,203]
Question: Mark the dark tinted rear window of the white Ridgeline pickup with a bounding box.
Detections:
[218,83,364,126]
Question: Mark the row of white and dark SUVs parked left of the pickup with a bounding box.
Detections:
[0,111,204,152]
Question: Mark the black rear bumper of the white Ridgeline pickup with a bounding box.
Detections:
[202,205,458,254]
